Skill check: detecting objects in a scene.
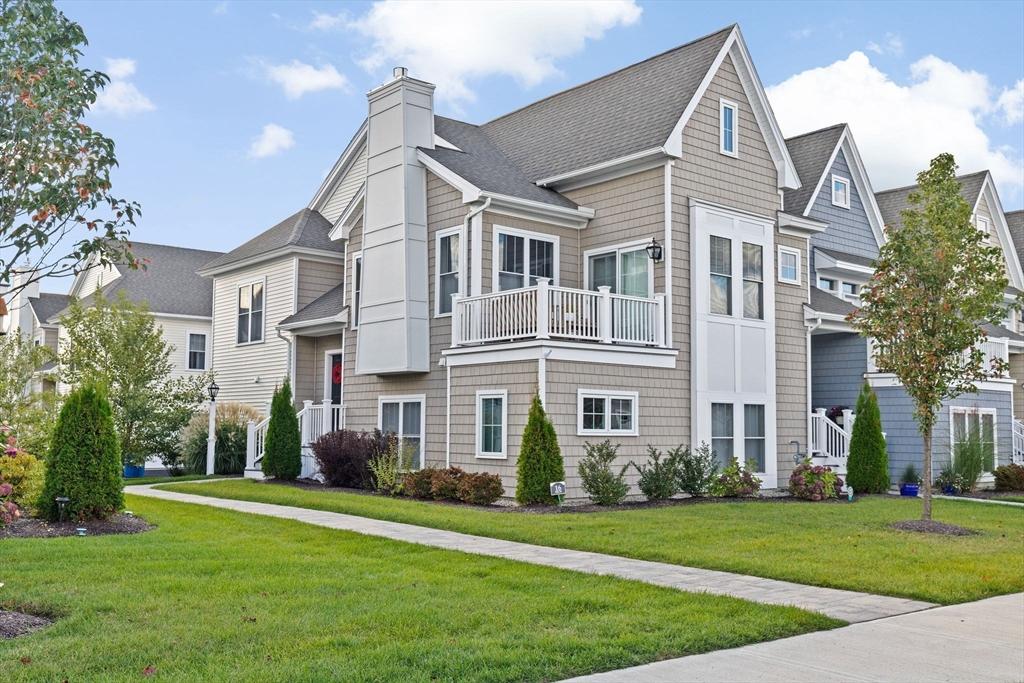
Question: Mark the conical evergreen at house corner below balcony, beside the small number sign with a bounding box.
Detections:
[515,395,565,505]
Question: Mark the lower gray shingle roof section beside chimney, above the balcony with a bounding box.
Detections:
[423,116,577,209]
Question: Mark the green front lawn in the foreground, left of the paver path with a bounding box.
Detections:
[0,495,839,683]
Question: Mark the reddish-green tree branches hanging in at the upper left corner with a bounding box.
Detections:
[0,0,139,293]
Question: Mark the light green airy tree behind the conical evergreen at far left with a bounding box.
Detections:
[60,292,209,465]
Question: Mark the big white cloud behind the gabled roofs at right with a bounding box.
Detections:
[767,52,1024,202]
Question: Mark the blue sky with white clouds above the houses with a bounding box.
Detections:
[58,0,1024,288]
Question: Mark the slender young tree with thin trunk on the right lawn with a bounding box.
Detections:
[850,154,1007,520]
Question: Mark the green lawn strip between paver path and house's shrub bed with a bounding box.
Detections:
[159,480,1024,604]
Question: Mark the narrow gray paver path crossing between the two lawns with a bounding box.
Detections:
[134,484,935,624]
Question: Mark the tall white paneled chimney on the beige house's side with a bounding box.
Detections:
[355,67,434,375]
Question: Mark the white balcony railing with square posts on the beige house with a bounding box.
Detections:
[452,279,665,346]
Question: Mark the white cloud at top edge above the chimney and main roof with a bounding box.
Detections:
[348,0,643,106]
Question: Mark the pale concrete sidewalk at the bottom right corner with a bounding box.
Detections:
[572,593,1024,683]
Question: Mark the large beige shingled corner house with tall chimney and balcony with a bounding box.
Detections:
[214,26,825,498]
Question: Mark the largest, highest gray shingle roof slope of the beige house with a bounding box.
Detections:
[480,26,733,181]
